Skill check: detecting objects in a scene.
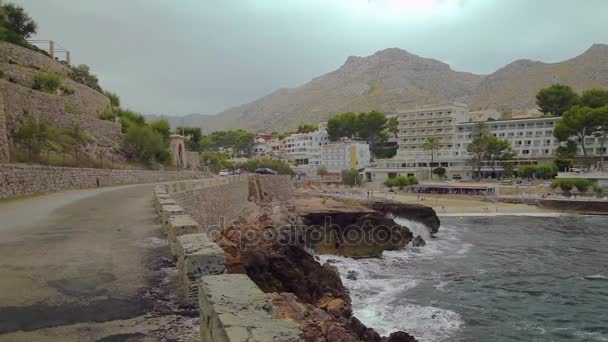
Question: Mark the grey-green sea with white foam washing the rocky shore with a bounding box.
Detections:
[320,216,608,342]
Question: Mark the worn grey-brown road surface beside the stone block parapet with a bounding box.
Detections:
[0,185,196,341]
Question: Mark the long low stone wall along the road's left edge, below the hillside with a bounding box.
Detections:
[0,164,209,199]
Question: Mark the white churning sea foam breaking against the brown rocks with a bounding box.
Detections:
[321,223,472,342]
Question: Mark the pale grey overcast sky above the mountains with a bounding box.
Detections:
[13,0,608,115]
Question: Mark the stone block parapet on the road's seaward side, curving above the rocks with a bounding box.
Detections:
[154,175,303,342]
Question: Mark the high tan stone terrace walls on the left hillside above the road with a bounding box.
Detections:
[0,42,125,162]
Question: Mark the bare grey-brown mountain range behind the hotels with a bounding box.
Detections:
[149,44,608,132]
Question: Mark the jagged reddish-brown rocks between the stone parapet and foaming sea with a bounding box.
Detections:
[218,203,416,342]
